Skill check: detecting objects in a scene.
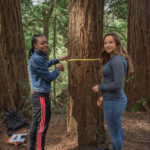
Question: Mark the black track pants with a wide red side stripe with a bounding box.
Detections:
[29,92,51,150]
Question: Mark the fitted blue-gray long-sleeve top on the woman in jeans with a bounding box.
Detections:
[98,54,128,100]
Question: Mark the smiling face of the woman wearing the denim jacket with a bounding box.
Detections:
[34,36,48,53]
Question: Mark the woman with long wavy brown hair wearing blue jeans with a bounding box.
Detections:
[92,33,133,150]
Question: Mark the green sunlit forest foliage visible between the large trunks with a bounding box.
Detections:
[22,0,127,113]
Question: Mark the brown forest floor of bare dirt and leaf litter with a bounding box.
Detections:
[0,112,150,150]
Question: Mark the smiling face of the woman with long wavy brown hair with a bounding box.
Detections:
[104,35,116,54]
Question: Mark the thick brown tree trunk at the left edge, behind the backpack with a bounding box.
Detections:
[0,0,29,111]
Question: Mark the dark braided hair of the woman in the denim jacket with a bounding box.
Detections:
[28,34,44,59]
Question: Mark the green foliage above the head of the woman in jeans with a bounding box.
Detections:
[104,0,127,47]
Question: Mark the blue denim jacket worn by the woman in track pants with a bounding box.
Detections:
[28,49,60,93]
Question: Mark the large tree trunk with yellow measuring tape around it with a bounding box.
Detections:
[67,0,105,146]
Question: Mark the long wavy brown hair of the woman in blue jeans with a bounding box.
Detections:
[100,32,134,75]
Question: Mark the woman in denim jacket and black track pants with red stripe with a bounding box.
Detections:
[29,34,67,150]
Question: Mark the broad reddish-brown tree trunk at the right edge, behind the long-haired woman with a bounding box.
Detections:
[126,0,150,110]
